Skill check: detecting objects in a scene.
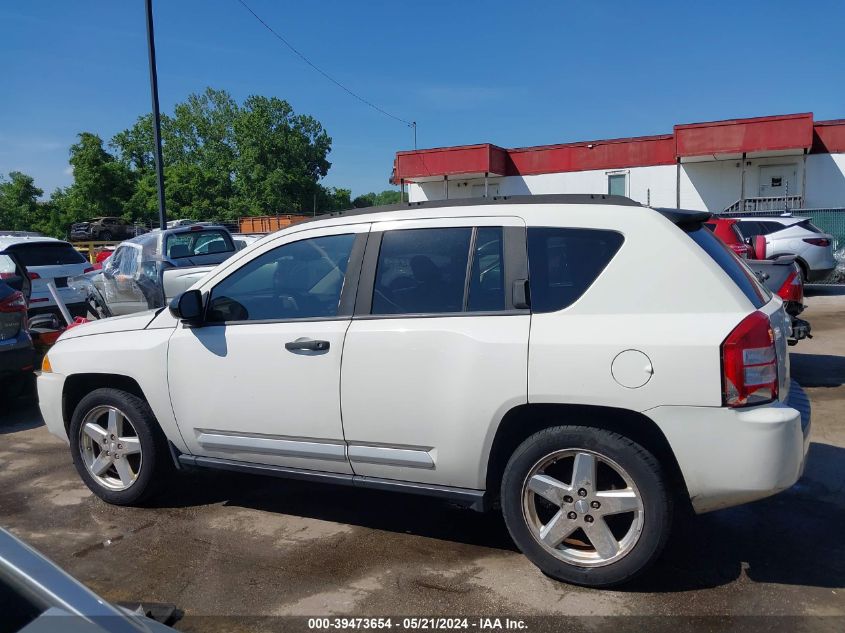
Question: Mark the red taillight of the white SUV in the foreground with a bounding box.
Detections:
[722,312,778,407]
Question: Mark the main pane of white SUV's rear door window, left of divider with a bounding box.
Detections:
[372,228,472,314]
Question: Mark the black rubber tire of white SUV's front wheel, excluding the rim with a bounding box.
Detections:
[68,388,174,506]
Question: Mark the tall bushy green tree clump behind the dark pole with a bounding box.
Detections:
[111,88,336,220]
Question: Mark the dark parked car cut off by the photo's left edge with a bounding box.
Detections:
[0,251,35,397]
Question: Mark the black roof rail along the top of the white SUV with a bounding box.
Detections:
[313,193,643,220]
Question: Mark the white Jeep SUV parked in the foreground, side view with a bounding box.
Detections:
[38,196,809,586]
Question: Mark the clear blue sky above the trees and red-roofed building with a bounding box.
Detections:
[0,0,845,195]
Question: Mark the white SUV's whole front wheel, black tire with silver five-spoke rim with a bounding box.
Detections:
[68,389,172,505]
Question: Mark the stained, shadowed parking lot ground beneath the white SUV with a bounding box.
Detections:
[0,294,845,631]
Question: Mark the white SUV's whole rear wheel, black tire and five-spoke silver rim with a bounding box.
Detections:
[502,426,672,587]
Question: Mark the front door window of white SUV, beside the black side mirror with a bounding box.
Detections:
[207,234,355,322]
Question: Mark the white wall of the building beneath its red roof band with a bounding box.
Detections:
[408,154,845,211]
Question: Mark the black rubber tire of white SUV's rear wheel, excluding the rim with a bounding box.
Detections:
[501,426,673,587]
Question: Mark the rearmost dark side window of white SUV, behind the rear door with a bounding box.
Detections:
[528,228,624,312]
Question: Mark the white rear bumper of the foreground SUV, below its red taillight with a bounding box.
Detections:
[645,381,810,513]
